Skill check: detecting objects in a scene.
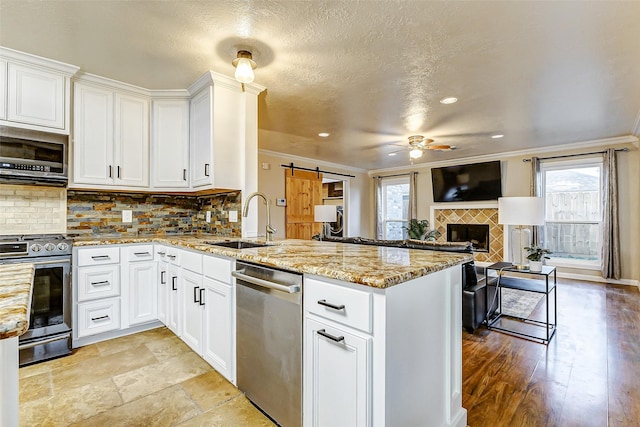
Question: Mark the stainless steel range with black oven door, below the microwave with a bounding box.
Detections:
[0,234,72,366]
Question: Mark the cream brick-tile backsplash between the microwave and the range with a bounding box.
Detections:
[0,184,67,235]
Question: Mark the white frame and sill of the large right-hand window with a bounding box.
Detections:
[540,156,604,270]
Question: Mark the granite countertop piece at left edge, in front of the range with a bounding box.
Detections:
[0,263,35,339]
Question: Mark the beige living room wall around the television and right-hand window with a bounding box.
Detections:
[369,144,640,283]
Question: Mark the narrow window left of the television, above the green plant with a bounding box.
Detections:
[382,177,409,240]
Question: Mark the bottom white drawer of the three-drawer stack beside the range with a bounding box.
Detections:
[78,298,120,337]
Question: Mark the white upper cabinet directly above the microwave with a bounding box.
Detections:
[0,47,78,134]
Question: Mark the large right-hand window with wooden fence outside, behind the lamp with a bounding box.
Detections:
[541,158,602,268]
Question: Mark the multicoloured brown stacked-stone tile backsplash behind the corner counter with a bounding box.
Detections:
[67,190,242,236]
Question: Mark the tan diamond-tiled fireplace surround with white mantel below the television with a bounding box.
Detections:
[431,203,504,263]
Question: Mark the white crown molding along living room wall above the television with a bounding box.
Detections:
[368,135,640,176]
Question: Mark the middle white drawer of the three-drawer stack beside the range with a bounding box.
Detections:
[77,264,120,301]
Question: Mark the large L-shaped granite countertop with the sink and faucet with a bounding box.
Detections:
[73,235,473,288]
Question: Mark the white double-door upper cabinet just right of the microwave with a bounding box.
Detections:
[73,77,149,187]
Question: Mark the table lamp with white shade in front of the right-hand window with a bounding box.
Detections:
[498,197,544,270]
